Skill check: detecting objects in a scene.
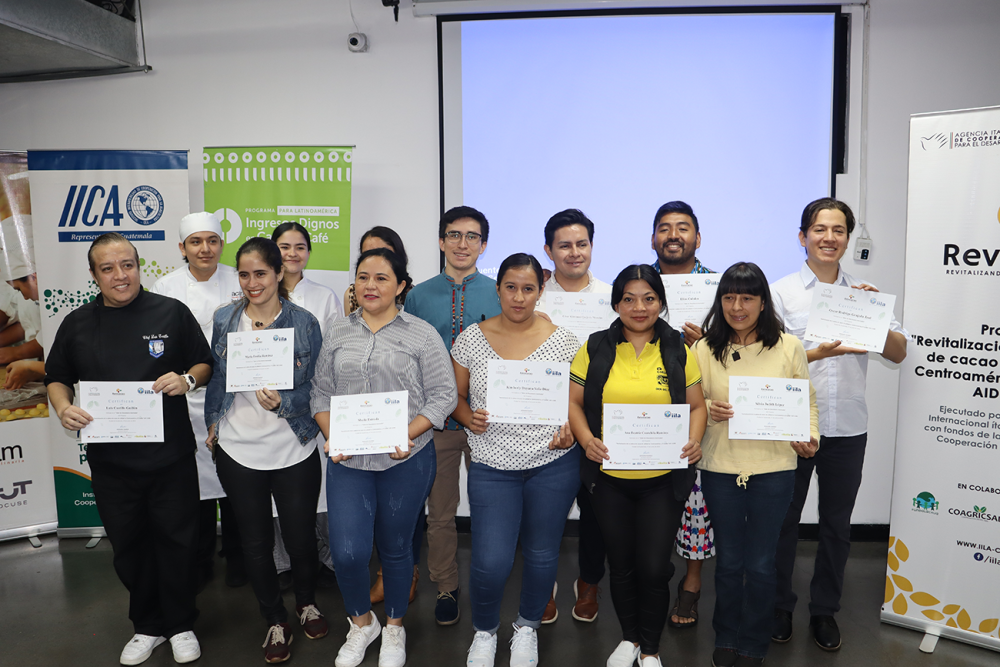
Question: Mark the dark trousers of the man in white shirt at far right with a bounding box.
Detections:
[774,433,868,616]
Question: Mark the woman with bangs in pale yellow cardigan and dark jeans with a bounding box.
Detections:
[692,262,819,667]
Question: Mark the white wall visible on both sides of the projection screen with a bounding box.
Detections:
[0,0,1000,523]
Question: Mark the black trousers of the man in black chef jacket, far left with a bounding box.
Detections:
[90,454,198,637]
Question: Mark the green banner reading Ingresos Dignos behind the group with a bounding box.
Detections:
[202,146,352,297]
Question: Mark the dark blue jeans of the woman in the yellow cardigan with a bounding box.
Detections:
[701,470,795,658]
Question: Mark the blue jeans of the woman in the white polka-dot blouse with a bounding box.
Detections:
[469,446,580,634]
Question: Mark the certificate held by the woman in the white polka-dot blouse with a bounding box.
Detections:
[486,359,569,426]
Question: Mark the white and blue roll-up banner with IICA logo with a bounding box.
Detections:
[28,151,188,537]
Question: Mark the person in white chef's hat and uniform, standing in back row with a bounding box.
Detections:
[150,211,247,589]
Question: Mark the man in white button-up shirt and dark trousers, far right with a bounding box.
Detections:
[771,198,907,651]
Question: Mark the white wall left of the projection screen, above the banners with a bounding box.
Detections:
[0,0,440,280]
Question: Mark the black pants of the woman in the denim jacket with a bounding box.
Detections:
[215,446,320,625]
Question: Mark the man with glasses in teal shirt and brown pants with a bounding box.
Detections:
[406,206,500,625]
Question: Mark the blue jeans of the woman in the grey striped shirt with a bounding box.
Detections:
[326,440,437,618]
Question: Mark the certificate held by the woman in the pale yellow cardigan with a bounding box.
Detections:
[729,376,809,442]
